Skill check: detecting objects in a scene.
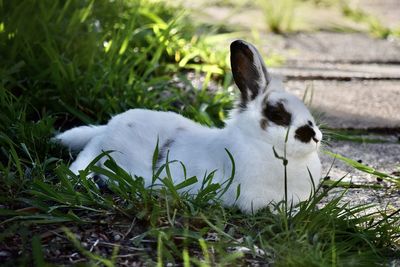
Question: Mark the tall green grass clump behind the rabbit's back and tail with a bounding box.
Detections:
[0,0,231,201]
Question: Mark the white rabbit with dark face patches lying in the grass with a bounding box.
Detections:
[56,40,322,212]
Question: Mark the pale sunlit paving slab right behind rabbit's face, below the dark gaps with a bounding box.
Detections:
[286,81,400,129]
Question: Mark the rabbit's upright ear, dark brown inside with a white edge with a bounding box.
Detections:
[231,40,270,107]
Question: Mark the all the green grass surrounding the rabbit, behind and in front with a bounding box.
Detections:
[0,0,399,266]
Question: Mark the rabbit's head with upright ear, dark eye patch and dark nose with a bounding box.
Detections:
[231,40,322,157]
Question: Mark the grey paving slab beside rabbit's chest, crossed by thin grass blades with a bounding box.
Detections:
[321,141,400,212]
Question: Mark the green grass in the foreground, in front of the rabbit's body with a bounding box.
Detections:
[1,155,398,266]
